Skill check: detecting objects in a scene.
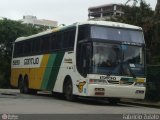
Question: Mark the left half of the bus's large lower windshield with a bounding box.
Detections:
[92,42,122,74]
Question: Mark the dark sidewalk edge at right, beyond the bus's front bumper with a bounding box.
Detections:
[121,99,160,108]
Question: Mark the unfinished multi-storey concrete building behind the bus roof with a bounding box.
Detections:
[88,4,124,20]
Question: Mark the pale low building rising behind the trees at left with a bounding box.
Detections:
[20,15,58,28]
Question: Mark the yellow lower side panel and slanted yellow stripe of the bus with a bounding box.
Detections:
[11,54,49,89]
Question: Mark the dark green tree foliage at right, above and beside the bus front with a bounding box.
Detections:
[111,0,160,64]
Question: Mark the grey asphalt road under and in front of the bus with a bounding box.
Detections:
[0,89,160,120]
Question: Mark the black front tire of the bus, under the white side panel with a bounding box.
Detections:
[64,80,74,101]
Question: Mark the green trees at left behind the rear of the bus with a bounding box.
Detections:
[0,19,44,88]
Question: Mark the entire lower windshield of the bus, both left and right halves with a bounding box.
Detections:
[90,42,144,76]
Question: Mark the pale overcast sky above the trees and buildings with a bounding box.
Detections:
[0,0,157,25]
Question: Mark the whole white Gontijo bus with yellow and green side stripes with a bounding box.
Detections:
[11,21,146,102]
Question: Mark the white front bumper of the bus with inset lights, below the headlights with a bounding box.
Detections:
[87,84,146,99]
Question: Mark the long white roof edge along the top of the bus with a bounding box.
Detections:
[15,21,142,42]
